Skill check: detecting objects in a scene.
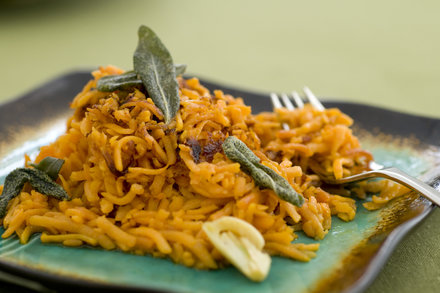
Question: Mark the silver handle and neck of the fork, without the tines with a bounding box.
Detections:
[338,167,440,206]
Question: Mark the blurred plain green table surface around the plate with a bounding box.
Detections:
[0,0,440,293]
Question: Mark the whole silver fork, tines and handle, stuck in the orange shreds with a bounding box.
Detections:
[270,87,440,206]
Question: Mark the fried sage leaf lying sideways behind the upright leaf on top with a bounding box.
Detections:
[96,64,186,92]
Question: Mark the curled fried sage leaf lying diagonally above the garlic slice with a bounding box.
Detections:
[222,136,304,206]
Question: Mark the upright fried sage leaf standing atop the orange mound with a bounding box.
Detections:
[133,26,180,124]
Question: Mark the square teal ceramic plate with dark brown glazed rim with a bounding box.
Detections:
[0,72,440,293]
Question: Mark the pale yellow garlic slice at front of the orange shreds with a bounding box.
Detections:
[202,217,271,282]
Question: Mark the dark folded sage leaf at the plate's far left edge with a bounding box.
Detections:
[0,164,70,218]
